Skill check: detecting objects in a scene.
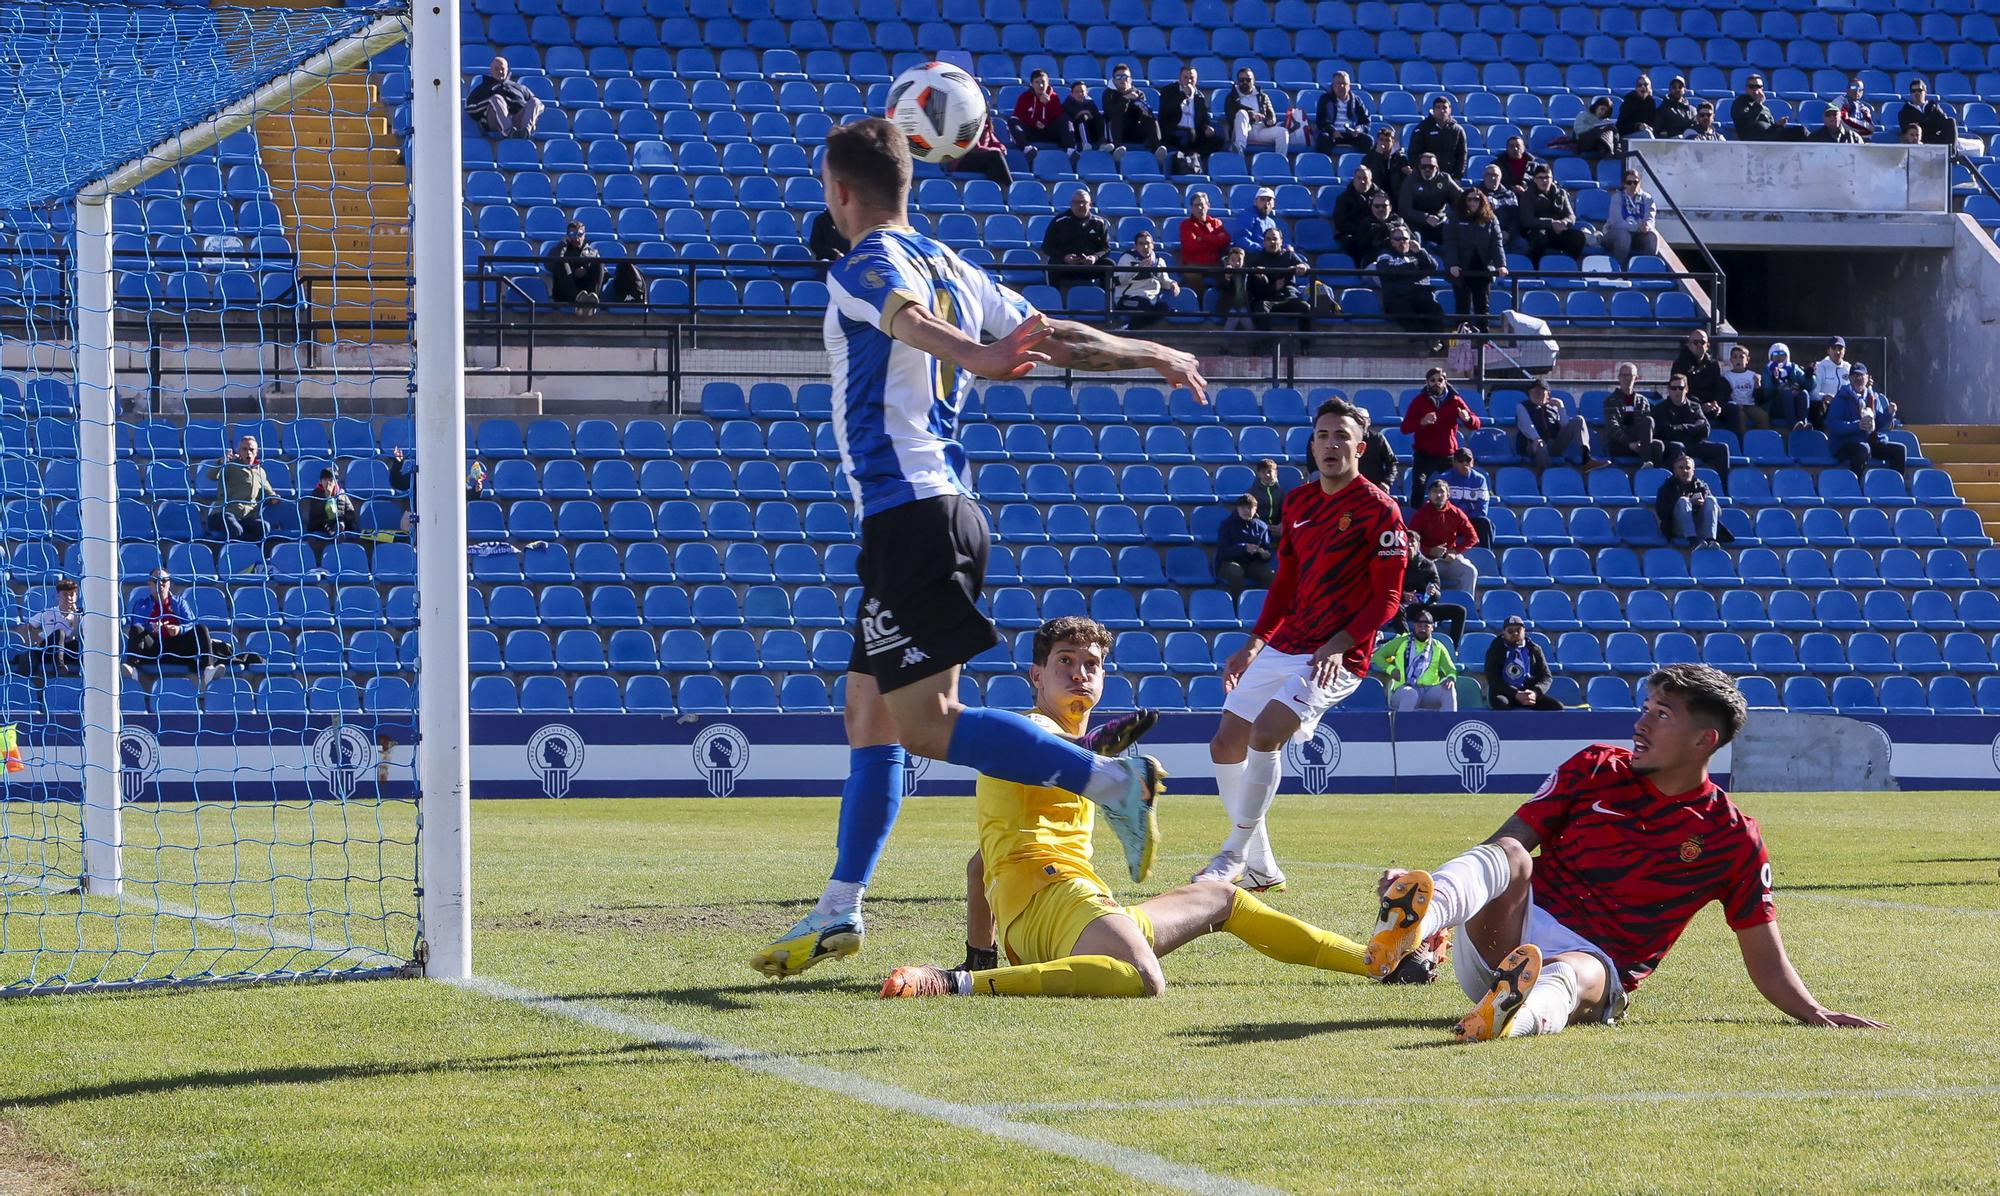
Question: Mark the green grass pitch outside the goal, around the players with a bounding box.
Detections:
[0,794,2000,1194]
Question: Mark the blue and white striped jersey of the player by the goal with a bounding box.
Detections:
[824,224,1034,518]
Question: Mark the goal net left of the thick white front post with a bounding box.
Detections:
[0,0,464,994]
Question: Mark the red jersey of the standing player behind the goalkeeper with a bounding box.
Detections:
[1256,476,1410,676]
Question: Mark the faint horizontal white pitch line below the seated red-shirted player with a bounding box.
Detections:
[978,1084,2000,1116]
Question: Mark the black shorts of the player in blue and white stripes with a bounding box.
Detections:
[848,494,1000,694]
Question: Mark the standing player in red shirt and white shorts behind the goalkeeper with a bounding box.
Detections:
[1194,398,1408,892]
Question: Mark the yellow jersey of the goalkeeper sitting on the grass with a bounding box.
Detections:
[976,710,1104,926]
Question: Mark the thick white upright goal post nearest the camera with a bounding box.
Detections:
[410,0,472,980]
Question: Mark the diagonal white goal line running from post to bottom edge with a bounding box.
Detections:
[454,976,1278,1196]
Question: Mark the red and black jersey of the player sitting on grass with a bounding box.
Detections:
[1516,744,1778,992]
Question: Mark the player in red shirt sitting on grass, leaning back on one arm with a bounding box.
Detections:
[1368,664,1880,1040]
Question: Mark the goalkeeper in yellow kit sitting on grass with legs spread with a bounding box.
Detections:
[882,616,1428,996]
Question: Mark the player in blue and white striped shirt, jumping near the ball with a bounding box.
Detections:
[750,120,1206,976]
